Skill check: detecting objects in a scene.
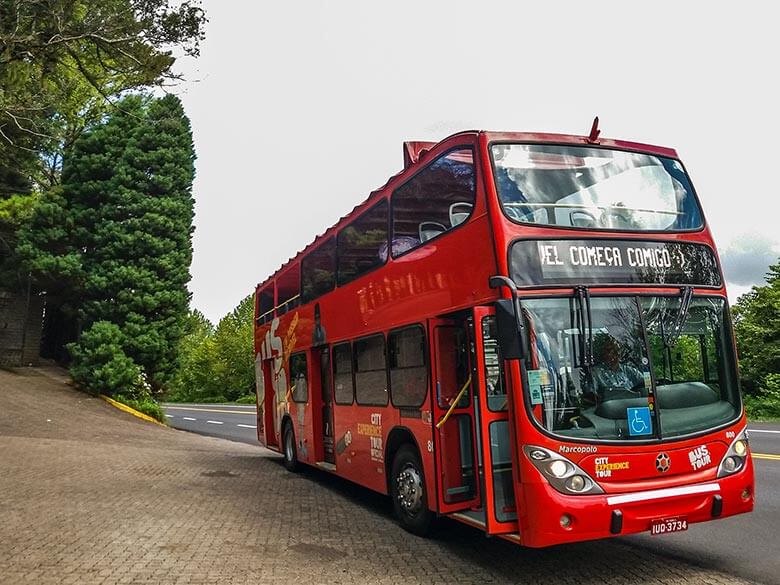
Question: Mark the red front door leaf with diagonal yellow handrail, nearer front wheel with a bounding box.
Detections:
[428,319,479,513]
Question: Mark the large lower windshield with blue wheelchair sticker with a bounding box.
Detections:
[523,296,740,441]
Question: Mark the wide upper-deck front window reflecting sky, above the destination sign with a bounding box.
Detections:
[491,144,703,231]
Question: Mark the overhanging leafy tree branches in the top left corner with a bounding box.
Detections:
[0,0,206,187]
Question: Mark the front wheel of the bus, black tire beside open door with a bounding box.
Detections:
[390,445,434,536]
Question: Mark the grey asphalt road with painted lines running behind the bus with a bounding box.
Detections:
[163,404,780,585]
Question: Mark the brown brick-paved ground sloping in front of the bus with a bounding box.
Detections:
[0,371,760,585]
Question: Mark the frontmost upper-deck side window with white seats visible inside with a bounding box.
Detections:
[392,148,477,258]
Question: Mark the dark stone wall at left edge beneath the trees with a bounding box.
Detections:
[0,290,44,367]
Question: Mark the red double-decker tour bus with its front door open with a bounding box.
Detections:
[255,126,753,547]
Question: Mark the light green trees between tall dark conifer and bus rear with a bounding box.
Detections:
[167,295,255,403]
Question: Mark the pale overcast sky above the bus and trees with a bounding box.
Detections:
[176,0,780,321]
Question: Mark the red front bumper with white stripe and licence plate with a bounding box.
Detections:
[520,460,754,547]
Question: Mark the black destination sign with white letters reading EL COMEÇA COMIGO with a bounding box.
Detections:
[509,239,721,287]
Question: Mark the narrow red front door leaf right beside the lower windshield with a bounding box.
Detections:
[474,307,518,534]
